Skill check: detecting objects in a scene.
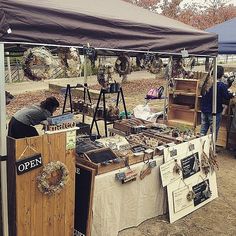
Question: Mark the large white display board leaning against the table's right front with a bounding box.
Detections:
[164,135,218,223]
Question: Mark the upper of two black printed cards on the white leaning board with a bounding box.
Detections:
[181,152,200,179]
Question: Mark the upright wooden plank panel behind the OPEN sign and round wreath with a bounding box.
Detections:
[7,132,75,236]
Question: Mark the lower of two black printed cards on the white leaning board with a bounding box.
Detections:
[193,179,211,206]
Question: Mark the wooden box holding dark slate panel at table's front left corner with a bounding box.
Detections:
[77,148,125,175]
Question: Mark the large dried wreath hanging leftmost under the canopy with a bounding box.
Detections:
[23,47,53,81]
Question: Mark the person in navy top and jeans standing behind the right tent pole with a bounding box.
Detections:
[200,66,233,139]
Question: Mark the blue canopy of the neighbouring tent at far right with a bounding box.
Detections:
[206,18,236,54]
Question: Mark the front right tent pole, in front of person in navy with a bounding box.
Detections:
[212,57,217,152]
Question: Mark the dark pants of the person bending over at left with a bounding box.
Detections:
[8,117,39,139]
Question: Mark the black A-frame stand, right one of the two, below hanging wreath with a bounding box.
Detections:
[91,87,128,137]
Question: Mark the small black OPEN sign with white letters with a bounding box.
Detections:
[16,153,43,175]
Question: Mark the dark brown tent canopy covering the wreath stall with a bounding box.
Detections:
[0,0,218,56]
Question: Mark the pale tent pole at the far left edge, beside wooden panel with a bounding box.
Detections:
[0,43,9,236]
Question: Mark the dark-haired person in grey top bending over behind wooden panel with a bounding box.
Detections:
[8,96,59,139]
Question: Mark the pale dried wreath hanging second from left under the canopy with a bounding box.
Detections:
[58,47,81,76]
